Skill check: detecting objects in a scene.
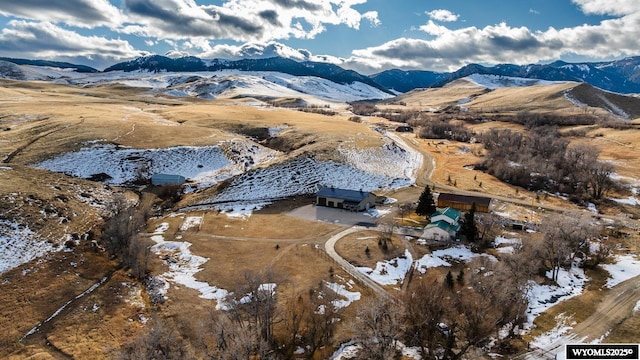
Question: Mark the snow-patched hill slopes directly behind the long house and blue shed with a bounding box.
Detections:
[34,133,422,217]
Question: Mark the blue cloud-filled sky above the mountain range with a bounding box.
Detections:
[0,0,640,74]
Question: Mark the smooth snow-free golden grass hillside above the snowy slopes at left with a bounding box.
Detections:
[0,81,382,164]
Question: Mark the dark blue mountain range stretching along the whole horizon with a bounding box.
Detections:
[0,55,640,94]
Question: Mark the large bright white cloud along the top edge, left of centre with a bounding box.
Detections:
[120,0,380,42]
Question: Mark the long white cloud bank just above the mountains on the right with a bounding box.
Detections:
[346,7,640,72]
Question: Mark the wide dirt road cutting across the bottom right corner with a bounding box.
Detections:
[518,276,640,360]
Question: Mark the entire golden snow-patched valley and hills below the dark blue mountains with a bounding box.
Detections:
[0,65,640,359]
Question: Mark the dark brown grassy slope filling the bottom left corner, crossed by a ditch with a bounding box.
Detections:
[0,243,126,358]
